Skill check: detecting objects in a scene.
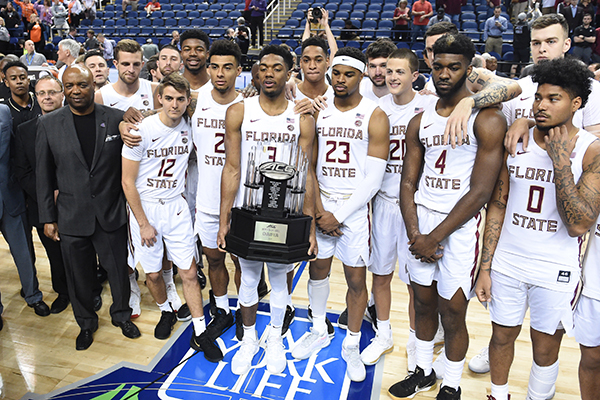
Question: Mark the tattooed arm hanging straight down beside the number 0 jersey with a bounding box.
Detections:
[475,153,509,303]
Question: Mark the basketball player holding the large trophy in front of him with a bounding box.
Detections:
[217,45,316,375]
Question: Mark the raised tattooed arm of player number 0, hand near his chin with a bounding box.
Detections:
[544,125,600,237]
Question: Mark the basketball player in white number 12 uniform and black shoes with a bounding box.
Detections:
[122,73,223,362]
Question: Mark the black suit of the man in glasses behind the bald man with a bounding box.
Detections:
[13,117,69,297]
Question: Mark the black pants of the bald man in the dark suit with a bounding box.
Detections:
[60,221,131,330]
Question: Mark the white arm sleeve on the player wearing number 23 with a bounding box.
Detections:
[333,156,387,223]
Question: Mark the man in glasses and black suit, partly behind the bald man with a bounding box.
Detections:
[13,75,69,314]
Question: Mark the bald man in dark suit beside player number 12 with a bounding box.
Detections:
[35,65,140,350]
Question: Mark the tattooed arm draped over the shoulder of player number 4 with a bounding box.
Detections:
[444,68,521,147]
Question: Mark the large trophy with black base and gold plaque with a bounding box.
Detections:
[225,141,312,264]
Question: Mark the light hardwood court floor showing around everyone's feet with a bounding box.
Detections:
[0,233,579,400]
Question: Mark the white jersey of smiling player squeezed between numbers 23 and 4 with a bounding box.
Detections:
[379,93,437,200]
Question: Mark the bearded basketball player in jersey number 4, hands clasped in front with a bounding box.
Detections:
[389,34,506,400]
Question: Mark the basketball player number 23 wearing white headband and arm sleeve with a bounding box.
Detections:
[292,47,390,382]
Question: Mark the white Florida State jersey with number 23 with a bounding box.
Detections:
[317,97,377,194]
